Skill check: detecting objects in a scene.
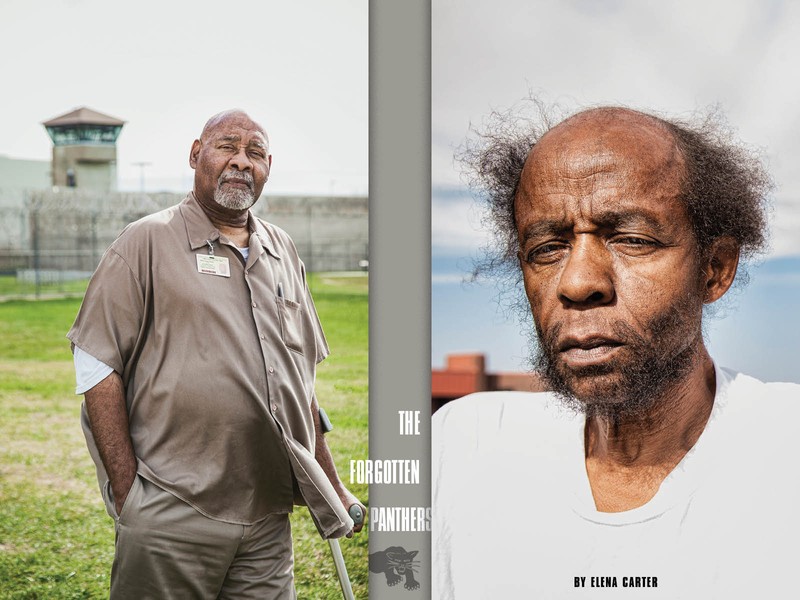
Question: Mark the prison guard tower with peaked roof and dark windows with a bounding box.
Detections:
[42,106,125,192]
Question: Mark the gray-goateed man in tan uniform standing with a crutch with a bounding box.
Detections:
[68,111,363,599]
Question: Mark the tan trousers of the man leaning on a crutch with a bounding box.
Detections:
[104,476,296,600]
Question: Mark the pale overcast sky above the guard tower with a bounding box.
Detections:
[0,0,368,194]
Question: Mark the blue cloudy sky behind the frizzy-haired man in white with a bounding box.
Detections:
[431,0,800,382]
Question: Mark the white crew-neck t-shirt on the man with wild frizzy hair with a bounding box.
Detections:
[432,368,800,600]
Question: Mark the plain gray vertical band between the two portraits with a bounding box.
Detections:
[369,0,431,600]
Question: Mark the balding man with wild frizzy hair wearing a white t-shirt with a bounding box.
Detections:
[432,104,800,600]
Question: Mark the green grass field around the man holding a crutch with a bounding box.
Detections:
[0,274,368,600]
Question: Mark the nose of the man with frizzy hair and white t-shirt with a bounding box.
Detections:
[557,239,615,308]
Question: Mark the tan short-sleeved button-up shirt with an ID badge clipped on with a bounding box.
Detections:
[67,194,352,537]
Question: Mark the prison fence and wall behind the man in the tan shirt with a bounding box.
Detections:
[0,190,369,299]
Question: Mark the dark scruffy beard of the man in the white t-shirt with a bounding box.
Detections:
[532,302,702,423]
